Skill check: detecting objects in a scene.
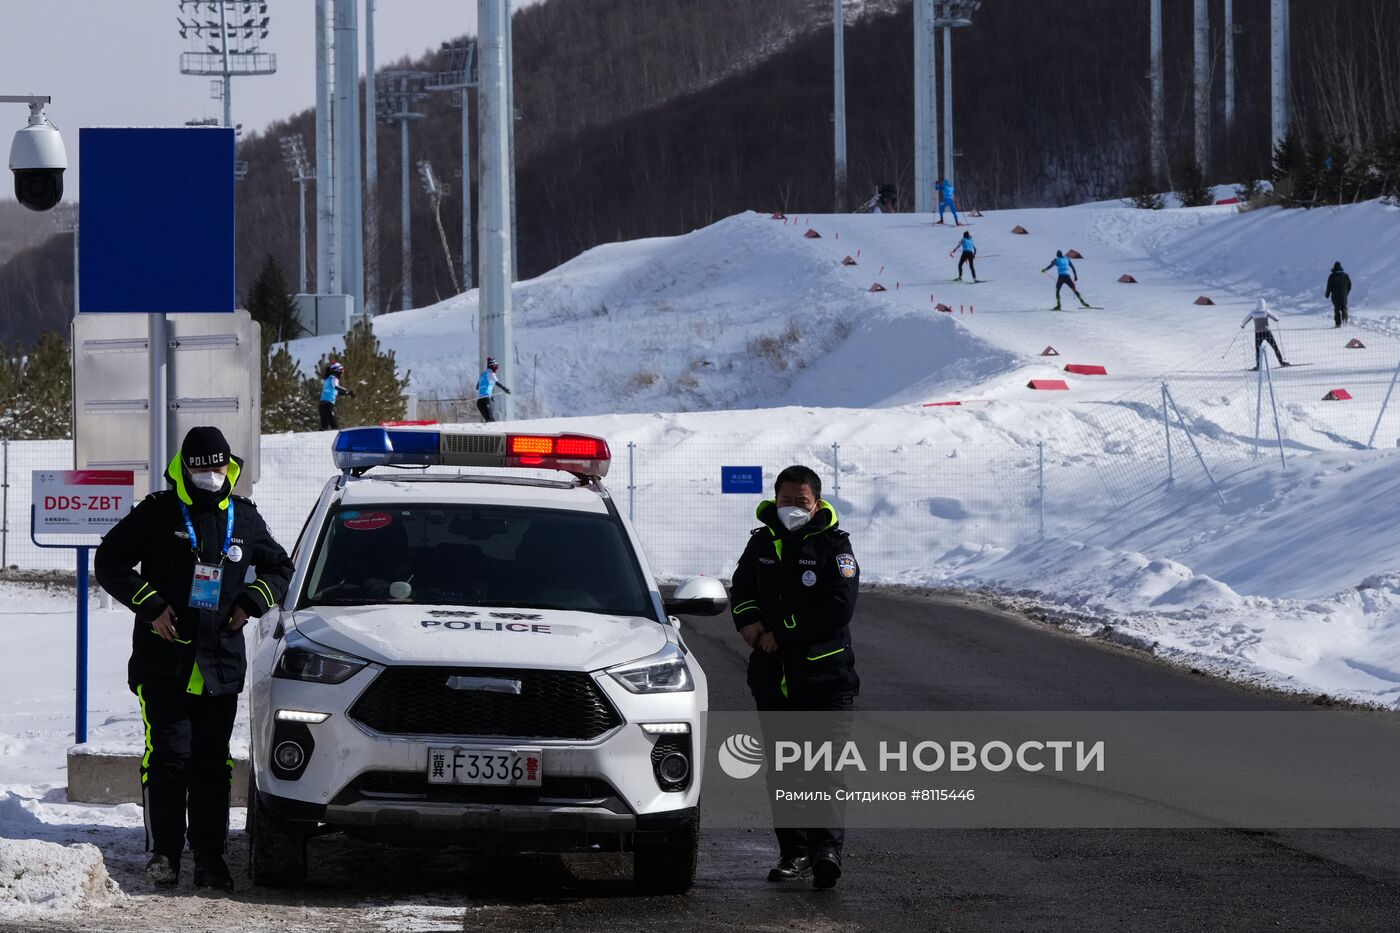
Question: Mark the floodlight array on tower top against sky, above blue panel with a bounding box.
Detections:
[175,0,277,126]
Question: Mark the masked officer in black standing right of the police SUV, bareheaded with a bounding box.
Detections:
[731,467,861,888]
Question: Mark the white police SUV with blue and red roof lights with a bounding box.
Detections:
[248,427,727,892]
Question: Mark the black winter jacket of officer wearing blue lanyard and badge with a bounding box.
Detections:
[94,454,293,696]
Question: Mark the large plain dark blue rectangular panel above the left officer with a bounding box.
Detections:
[78,126,235,314]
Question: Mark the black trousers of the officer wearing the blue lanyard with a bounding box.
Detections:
[136,684,238,864]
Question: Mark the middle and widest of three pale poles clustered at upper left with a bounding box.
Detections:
[335,0,364,314]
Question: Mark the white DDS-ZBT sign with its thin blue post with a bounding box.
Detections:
[29,469,136,745]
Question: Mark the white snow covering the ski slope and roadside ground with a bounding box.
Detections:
[0,194,1400,919]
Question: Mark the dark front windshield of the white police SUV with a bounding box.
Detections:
[301,504,654,616]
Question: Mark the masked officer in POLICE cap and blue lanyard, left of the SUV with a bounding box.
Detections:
[94,427,293,891]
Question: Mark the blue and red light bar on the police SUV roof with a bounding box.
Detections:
[332,427,612,478]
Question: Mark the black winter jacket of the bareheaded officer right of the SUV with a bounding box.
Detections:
[729,500,861,698]
